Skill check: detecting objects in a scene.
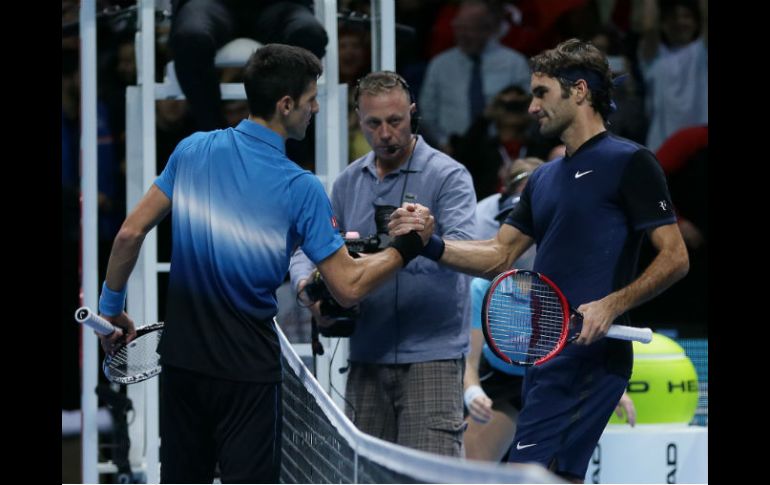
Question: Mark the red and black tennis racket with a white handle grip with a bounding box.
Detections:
[481,269,652,366]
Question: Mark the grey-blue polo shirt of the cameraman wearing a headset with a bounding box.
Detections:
[291,137,476,364]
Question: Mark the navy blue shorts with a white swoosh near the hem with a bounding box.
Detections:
[507,356,628,479]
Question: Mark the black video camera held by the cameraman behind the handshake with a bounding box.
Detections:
[302,205,396,337]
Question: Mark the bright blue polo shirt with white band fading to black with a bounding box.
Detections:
[155,120,344,382]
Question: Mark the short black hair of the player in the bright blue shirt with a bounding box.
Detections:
[243,44,323,121]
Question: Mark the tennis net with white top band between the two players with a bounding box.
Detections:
[276,326,564,483]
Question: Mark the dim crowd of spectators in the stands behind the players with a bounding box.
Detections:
[61,0,708,409]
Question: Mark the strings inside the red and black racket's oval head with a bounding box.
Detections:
[487,274,564,364]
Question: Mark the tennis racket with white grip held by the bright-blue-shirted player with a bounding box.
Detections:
[75,307,163,384]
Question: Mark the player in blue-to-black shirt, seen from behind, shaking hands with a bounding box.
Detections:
[93,44,430,483]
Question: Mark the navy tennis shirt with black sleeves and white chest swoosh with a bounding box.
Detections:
[505,131,676,377]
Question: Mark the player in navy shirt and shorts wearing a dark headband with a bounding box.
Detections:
[390,39,689,483]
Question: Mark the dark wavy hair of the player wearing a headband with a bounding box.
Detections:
[530,39,613,120]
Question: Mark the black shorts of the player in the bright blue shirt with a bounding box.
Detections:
[160,365,282,483]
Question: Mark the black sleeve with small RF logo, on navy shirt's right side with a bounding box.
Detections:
[620,149,676,231]
